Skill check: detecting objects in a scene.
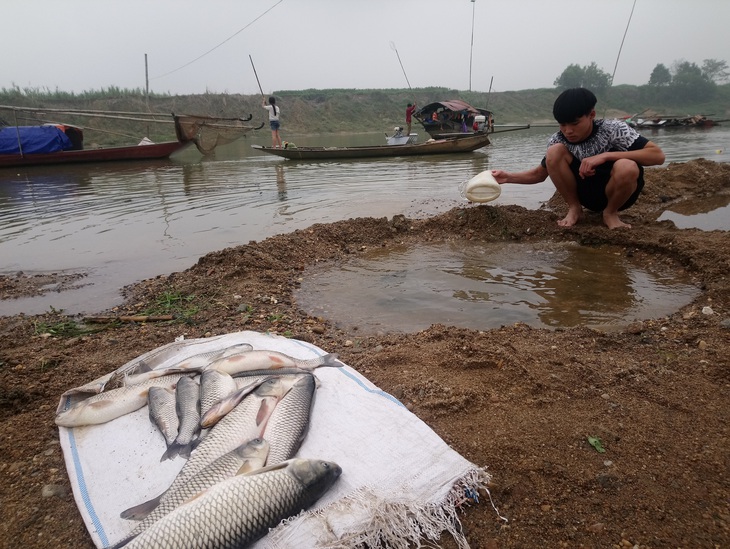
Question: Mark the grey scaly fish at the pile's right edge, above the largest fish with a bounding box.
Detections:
[264,373,317,466]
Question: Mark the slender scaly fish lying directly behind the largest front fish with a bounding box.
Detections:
[111,438,269,549]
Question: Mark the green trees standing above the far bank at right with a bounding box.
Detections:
[553,59,730,102]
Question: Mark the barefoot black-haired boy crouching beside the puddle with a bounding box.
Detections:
[492,88,664,229]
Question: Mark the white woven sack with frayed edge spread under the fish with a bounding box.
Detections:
[59,332,500,549]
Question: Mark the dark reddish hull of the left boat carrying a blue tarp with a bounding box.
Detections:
[0,141,192,168]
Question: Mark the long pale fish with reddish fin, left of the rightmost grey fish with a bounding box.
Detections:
[119,376,298,520]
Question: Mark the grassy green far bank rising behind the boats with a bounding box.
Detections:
[0,84,730,144]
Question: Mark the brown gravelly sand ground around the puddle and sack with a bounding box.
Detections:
[0,160,730,549]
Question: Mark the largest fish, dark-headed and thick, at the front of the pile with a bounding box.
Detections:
[126,459,342,549]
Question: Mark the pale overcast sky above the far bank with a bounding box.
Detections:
[5,0,730,94]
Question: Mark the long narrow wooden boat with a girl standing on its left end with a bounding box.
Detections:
[251,134,489,160]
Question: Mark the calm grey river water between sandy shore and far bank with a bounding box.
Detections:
[0,126,730,315]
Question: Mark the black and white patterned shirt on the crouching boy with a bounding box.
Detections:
[542,120,649,166]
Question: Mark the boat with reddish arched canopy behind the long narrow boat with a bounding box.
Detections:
[413,99,494,139]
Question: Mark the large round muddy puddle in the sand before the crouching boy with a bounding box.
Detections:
[296,241,699,334]
